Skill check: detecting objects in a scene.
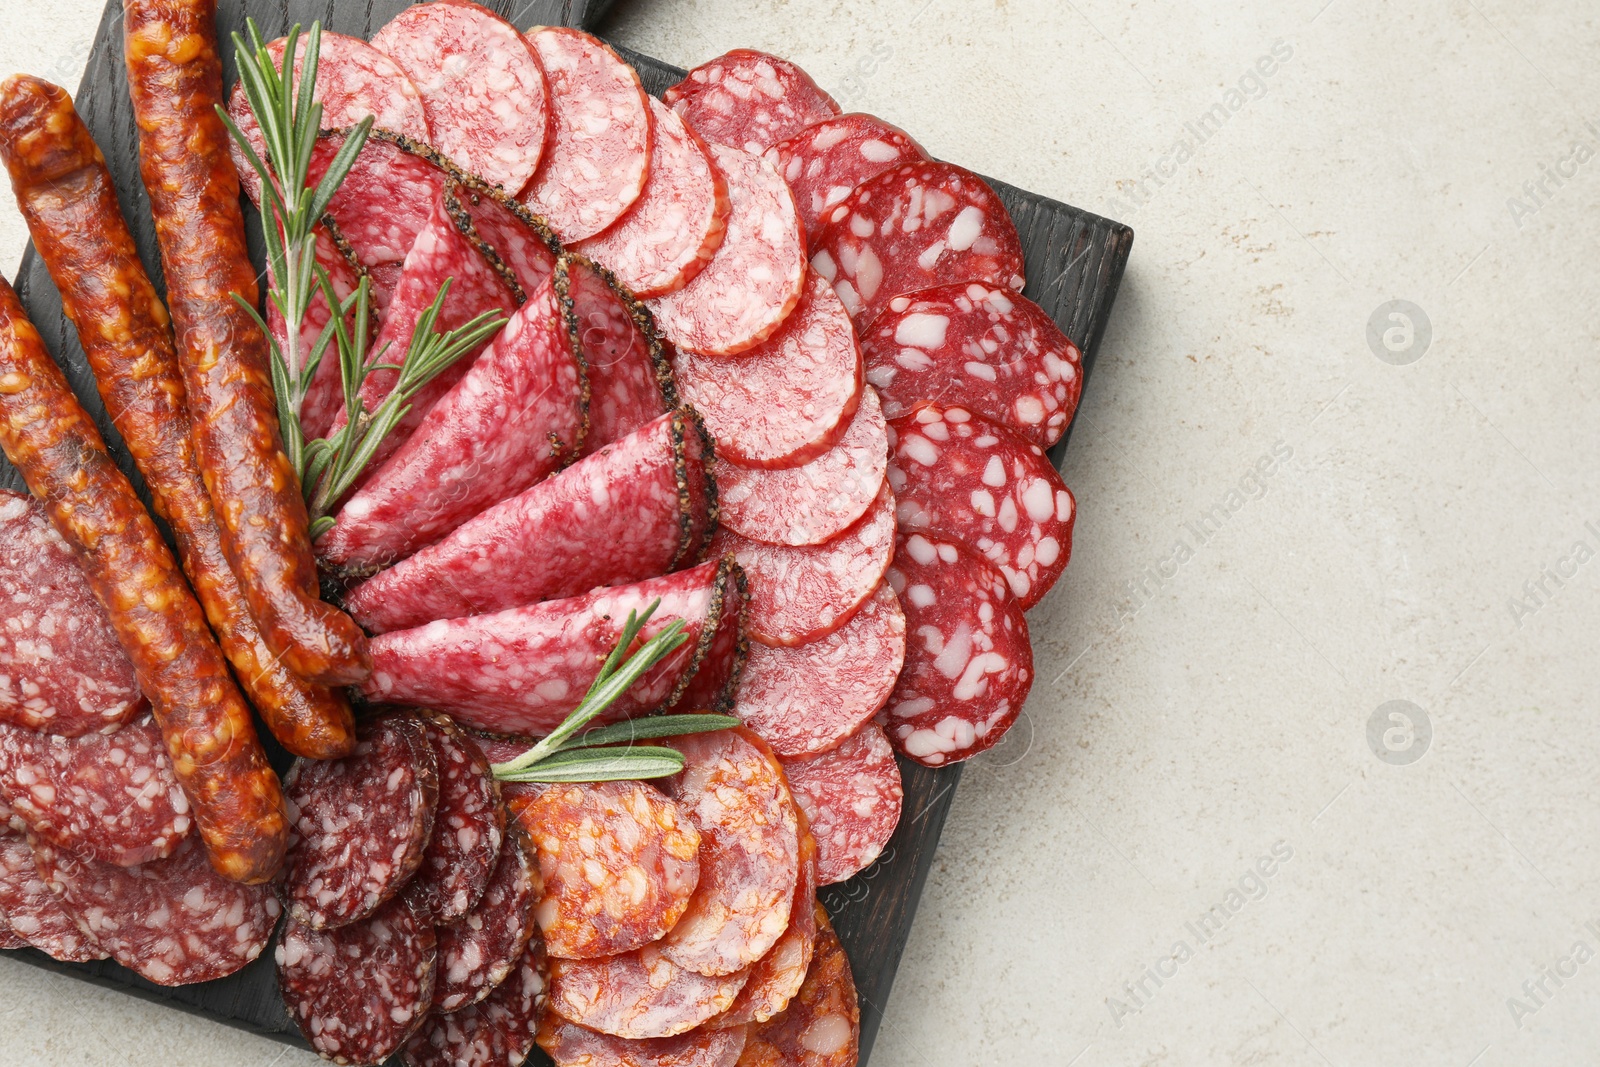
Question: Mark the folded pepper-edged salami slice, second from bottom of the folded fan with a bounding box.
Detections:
[346,413,709,633]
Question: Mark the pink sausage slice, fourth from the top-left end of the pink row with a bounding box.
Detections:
[578,98,728,299]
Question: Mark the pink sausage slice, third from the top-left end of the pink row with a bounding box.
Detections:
[522,26,653,242]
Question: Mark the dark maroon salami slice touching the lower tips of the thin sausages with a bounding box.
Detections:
[283,715,438,929]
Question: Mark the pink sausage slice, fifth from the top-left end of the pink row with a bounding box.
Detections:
[650,144,805,355]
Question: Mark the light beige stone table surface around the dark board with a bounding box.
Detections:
[0,0,1600,1067]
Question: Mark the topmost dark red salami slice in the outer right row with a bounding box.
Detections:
[661,48,838,154]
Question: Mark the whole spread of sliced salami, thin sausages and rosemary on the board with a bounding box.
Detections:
[0,0,1083,1067]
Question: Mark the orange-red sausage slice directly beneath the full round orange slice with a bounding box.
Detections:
[550,945,750,1040]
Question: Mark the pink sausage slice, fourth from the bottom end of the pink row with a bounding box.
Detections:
[717,389,890,545]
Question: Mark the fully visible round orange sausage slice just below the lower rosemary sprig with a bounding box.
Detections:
[517,782,701,960]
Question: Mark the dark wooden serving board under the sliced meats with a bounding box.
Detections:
[0,0,1133,1062]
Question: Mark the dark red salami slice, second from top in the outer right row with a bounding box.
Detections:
[766,112,928,246]
